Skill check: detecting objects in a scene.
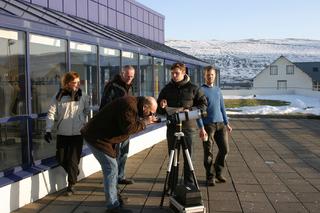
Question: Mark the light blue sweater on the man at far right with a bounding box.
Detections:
[201,84,228,125]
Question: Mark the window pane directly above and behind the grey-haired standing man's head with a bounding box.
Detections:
[122,51,140,96]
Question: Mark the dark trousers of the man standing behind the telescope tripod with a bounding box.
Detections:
[167,127,195,185]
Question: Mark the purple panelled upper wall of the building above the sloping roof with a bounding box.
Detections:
[24,0,165,43]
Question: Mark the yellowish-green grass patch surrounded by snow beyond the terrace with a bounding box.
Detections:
[224,99,290,108]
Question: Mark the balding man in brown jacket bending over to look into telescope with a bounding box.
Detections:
[81,96,157,213]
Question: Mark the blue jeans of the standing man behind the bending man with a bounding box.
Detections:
[117,139,129,180]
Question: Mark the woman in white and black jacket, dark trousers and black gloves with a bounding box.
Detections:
[44,71,89,195]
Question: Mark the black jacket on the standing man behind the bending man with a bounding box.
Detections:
[100,74,132,110]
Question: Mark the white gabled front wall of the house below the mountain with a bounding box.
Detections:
[253,56,312,90]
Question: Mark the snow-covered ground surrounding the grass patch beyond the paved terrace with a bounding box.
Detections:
[224,94,320,115]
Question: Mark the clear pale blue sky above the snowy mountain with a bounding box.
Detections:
[136,0,320,41]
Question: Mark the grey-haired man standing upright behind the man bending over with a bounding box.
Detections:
[100,65,135,184]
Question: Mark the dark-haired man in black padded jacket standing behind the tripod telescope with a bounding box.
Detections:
[158,63,207,189]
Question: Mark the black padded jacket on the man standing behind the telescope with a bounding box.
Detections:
[158,75,207,129]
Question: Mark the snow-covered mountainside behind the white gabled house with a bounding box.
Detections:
[166,39,320,83]
